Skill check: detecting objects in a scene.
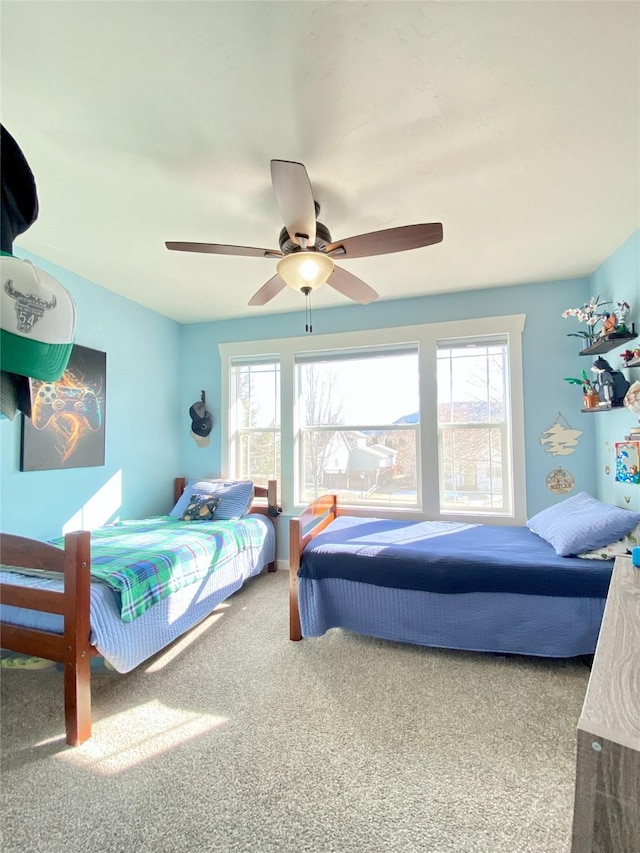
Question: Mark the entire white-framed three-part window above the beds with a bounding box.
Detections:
[219,315,526,524]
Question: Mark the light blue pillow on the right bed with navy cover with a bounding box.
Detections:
[527,492,640,557]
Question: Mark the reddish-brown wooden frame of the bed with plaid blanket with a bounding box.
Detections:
[0,477,281,746]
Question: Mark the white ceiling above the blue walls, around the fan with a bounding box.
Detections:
[0,0,640,323]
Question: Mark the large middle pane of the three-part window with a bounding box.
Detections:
[295,345,420,507]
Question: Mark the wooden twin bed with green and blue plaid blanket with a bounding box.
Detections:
[0,478,279,746]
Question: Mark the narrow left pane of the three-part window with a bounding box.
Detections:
[229,359,280,486]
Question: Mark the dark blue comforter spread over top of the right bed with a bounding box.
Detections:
[298,516,613,598]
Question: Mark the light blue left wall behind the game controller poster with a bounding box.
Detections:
[0,247,183,539]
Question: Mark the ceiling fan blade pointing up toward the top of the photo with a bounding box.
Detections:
[271,160,316,246]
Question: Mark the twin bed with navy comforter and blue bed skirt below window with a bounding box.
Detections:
[289,495,620,657]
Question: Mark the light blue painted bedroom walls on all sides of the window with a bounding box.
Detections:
[7,232,640,543]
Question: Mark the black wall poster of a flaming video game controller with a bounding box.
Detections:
[20,344,107,471]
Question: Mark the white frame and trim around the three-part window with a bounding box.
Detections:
[218,314,527,524]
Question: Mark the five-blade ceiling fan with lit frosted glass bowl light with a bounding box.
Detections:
[165,160,442,305]
